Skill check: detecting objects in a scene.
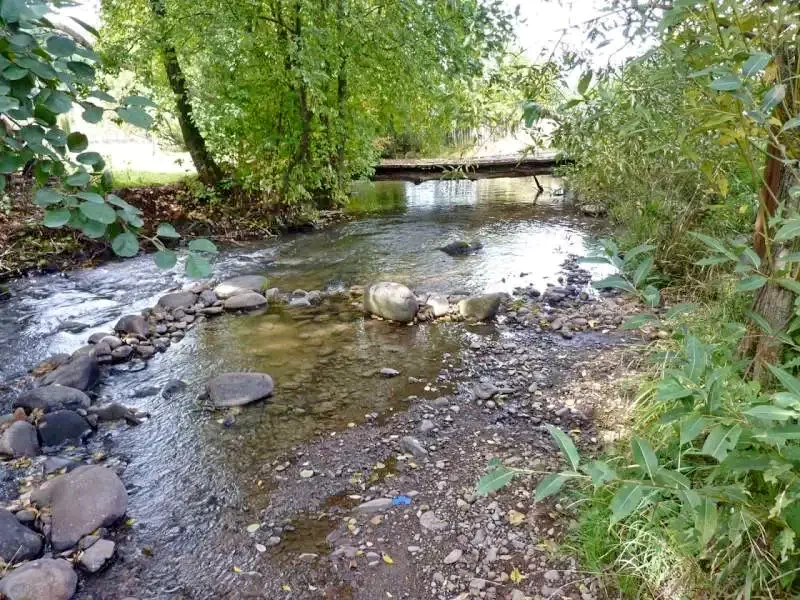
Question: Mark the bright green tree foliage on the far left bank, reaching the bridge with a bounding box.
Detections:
[101,0,512,209]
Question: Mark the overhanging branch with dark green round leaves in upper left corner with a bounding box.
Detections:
[0,0,212,276]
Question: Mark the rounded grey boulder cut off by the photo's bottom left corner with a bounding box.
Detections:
[0,558,78,600]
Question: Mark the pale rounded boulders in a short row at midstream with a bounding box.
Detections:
[360,281,508,323]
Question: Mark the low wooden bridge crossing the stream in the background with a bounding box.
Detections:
[373,152,572,183]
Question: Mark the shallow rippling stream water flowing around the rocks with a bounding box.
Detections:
[0,173,604,598]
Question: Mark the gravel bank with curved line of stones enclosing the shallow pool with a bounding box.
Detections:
[0,254,652,600]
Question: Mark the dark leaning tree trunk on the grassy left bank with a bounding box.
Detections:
[150,0,222,186]
